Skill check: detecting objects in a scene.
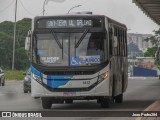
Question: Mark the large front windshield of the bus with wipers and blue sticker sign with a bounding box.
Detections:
[34,32,106,66]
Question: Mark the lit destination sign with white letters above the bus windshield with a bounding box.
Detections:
[38,19,93,28]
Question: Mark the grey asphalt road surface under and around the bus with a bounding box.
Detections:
[0,78,160,120]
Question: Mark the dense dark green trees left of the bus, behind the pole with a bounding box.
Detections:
[0,18,31,70]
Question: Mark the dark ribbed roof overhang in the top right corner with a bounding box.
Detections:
[133,0,160,25]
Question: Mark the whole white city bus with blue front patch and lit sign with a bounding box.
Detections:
[26,14,128,109]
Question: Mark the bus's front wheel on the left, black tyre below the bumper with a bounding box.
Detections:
[41,98,52,109]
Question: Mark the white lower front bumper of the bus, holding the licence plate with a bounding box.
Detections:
[31,80,111,99]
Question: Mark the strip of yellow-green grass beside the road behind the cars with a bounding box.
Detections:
[4,70,24,80]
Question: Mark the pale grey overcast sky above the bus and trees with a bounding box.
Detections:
[0,0,159,34]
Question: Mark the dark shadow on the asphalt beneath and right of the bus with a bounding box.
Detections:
[49,100,154,111]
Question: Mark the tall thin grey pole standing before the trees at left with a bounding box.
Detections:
[12,0,17,70]
